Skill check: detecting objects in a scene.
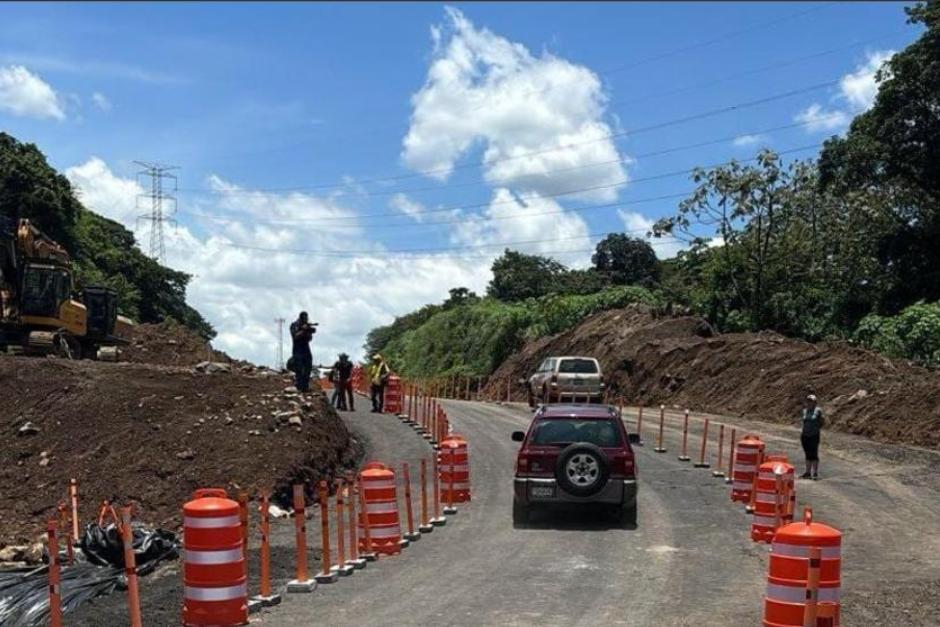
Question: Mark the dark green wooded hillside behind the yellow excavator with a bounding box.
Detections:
[0,133,215,339]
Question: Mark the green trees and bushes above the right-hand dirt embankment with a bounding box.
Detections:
[367,1,940,375]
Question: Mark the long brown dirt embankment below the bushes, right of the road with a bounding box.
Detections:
[484,306,940,447]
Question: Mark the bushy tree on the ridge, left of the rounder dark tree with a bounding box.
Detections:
[486,248,567,302]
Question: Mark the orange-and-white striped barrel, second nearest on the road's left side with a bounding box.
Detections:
[358,462,402,555]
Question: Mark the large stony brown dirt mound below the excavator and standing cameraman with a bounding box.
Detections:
[0,357,358,547]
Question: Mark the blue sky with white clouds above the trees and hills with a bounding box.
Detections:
[0,2,919,362]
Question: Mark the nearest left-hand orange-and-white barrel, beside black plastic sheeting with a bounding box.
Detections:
[183,488,248,625]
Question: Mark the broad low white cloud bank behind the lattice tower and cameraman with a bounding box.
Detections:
[67,158,489,364]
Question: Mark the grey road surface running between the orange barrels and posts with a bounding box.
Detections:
[263,401,940,626]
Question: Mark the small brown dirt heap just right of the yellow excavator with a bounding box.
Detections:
[120,322,234,366]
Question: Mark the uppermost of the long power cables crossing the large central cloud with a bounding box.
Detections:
[176,77,841,194]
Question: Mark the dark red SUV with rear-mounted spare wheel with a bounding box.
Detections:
[512,405,638,525]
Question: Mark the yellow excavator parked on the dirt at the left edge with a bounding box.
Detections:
[0,218,133,360]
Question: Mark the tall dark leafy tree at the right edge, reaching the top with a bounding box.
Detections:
[819,1,940,313]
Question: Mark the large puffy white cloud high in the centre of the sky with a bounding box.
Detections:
[402,8,627,201]
